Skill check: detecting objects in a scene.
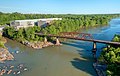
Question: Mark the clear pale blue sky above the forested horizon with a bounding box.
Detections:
[0,0,120,14]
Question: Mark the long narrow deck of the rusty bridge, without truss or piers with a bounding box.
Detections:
[35,33,120,46]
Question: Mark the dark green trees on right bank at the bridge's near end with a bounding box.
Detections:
[100,35,120,76]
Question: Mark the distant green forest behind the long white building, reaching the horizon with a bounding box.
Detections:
[0,12,120,26]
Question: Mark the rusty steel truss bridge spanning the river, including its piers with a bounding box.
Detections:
[35,32,120,58]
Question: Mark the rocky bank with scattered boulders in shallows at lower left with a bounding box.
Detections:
[0,35,28,76]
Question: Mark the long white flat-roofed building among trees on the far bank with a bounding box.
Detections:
[10,18,62,29]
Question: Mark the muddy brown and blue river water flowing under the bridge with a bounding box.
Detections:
[5,20,120,76]
